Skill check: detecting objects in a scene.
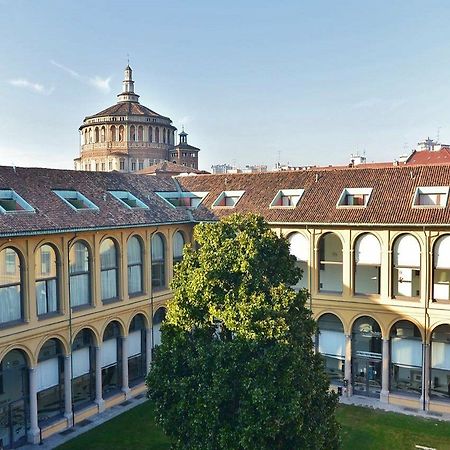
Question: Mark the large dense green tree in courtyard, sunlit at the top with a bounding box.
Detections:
[147,215,339,450]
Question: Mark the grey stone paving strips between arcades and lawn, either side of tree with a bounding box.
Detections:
[21,395,450,450]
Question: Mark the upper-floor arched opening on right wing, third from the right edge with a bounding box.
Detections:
[355,233,381,295]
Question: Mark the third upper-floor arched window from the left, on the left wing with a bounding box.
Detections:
[69,241,91,308]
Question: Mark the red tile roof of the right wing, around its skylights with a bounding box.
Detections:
[177,165,450,226]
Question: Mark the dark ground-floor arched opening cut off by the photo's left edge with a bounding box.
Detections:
[0,350,30,448]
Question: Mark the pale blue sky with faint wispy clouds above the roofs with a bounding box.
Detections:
[0,0,450,170]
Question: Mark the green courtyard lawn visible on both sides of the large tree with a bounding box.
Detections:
[58,402,450,450]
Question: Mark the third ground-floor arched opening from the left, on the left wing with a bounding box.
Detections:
[72,328,95,409]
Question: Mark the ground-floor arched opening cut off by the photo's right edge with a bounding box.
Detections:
[430,324,450,401]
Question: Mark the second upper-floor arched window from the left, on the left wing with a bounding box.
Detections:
[35,244,58,316]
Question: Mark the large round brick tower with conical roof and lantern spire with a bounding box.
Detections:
[75,65,176,172]
